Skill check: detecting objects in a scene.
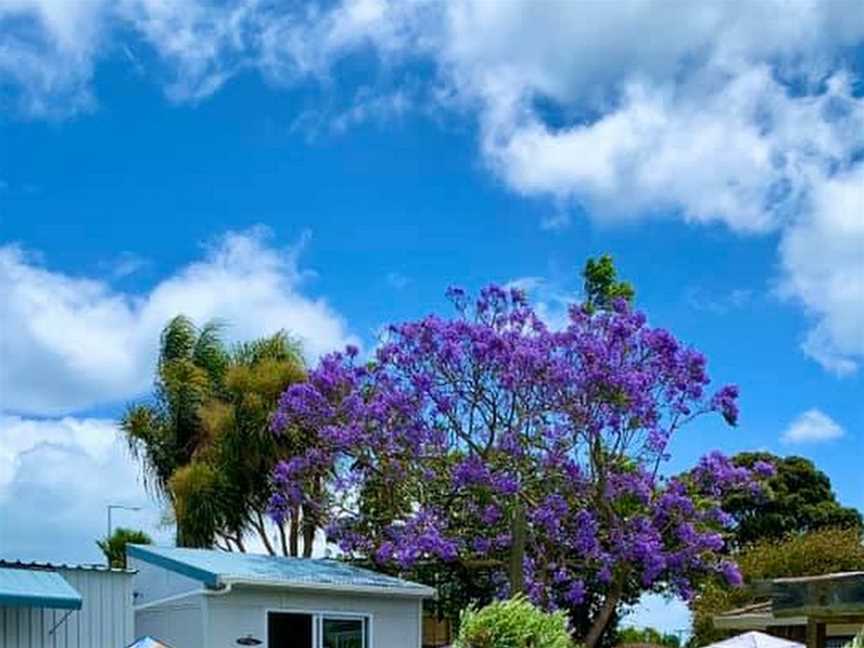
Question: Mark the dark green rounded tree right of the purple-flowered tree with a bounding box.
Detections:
[723,452,862,547]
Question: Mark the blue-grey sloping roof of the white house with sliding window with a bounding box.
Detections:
[126,545,434,596]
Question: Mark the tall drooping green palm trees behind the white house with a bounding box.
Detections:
[120,316,305,553]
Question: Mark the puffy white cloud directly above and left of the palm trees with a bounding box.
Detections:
[0,231,356,415]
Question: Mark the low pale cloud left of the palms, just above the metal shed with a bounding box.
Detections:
[0,415,170,562]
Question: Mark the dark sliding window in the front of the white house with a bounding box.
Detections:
[267,612,370,648]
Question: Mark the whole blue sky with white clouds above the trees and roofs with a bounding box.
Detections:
[0,0,864,627]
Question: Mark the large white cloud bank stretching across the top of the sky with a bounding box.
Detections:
[0,0,864,373]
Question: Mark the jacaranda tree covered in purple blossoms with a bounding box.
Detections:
[271,286,770,648]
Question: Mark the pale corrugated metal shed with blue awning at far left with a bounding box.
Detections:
[0,560,135,648]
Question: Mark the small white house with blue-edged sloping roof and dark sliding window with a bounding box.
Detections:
[127,545,435,648]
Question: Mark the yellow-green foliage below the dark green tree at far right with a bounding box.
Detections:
[691,529,864,646]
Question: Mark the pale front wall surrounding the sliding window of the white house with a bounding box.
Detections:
[205,587,421,648]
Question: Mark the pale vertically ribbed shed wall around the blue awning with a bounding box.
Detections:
[0,568,135,648]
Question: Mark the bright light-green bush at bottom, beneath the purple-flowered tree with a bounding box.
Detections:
[454,596,573,648]
